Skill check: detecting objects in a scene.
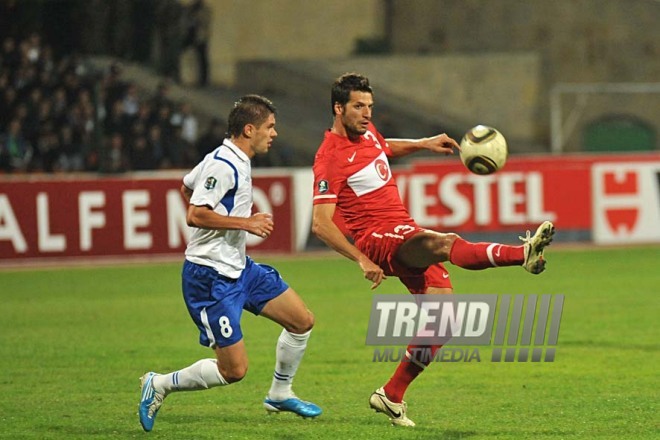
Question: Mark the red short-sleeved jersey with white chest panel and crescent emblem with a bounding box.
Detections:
[314,123,414,238]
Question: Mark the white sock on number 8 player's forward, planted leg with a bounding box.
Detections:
[268,330,312,400]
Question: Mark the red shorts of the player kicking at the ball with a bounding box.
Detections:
[355,223,452,293]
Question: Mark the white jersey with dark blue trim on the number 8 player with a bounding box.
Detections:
[183,139,252,279]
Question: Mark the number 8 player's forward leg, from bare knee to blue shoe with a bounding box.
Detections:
[261,288,322,417]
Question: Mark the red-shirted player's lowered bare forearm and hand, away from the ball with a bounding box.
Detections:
[312,203,385,289]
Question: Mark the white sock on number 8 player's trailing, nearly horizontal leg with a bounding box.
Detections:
[153,359,227,395]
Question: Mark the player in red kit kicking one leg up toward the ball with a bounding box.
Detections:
[312,73,554,426]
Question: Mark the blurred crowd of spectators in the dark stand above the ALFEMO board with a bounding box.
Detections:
[0,33,225,173]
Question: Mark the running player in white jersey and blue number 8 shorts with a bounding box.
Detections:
[139,95,321,431]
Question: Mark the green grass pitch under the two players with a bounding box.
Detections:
[0,247,660,440]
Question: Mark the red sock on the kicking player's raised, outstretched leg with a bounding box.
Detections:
[449,238,525,270]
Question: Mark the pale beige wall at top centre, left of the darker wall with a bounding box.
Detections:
[207,0,383,85]
